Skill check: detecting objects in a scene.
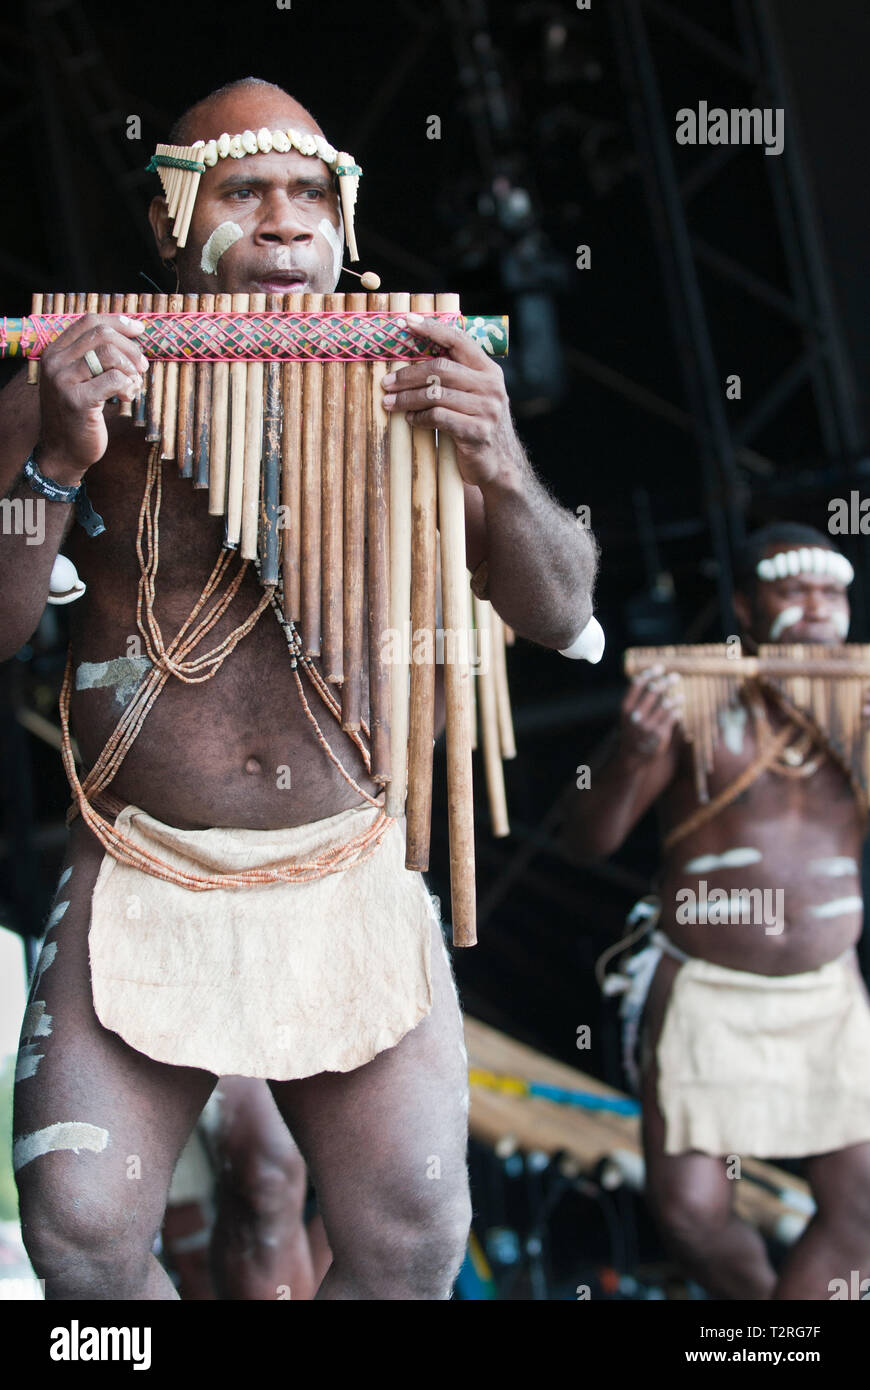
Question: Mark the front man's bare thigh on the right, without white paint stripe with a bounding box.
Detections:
[271,924,468,1252]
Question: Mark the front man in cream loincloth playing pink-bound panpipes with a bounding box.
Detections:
[0,79,595,1300]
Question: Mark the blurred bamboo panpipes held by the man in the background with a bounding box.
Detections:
[624,642,870,801]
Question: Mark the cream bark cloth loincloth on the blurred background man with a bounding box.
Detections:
[621,931,870,1158]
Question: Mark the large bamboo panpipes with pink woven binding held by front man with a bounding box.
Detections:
[15,293,516,945]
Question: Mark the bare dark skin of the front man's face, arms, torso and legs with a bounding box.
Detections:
[10,88,595,1300]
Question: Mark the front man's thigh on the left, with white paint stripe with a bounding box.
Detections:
[14,821,215,1240]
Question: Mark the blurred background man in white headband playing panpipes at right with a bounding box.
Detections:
[566,523,870,1298]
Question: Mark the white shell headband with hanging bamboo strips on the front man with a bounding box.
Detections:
[147,125,363,261]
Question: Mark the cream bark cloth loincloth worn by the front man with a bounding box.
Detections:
[89,806,438,1080]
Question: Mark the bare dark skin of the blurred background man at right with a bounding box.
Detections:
[566,542,870,1300]
